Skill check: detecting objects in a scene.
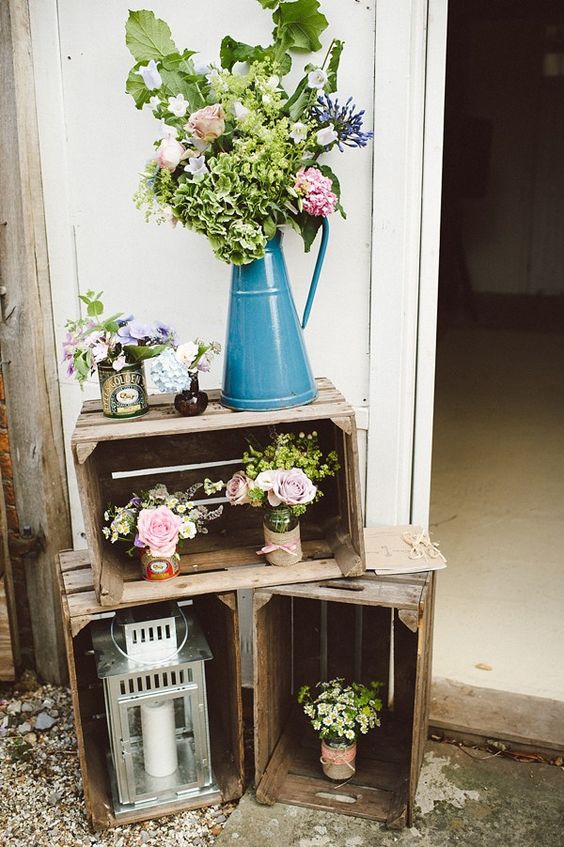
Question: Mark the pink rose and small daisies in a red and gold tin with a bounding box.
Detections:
[102,482,223,580]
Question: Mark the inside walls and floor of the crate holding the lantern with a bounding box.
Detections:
[72,594,244,829]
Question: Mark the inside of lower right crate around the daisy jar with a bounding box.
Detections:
[255,595,418,823]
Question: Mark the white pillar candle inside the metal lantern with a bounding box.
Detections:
[141,700,178,776]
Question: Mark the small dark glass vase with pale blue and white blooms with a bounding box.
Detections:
[151,338,221,417]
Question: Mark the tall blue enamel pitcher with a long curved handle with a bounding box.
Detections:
[221,218,329,411]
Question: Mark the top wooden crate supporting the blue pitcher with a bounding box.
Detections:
[72,380,364,605]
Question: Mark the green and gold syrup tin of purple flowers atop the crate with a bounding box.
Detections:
[63,291,174,418]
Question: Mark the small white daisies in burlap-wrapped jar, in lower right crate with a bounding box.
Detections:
[298,677,382,781]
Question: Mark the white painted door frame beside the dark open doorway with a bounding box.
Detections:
[366,0,448,526]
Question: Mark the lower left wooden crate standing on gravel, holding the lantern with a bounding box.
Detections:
[59,551,244,829]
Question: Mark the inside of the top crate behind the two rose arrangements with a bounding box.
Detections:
[81,419,359,599]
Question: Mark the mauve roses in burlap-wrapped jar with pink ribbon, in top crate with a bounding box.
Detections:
[204,431,339,566]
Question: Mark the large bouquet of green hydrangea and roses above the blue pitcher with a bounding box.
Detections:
[126,0,372,265]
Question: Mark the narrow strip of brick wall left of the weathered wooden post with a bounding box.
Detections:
[0,369,34,668]
